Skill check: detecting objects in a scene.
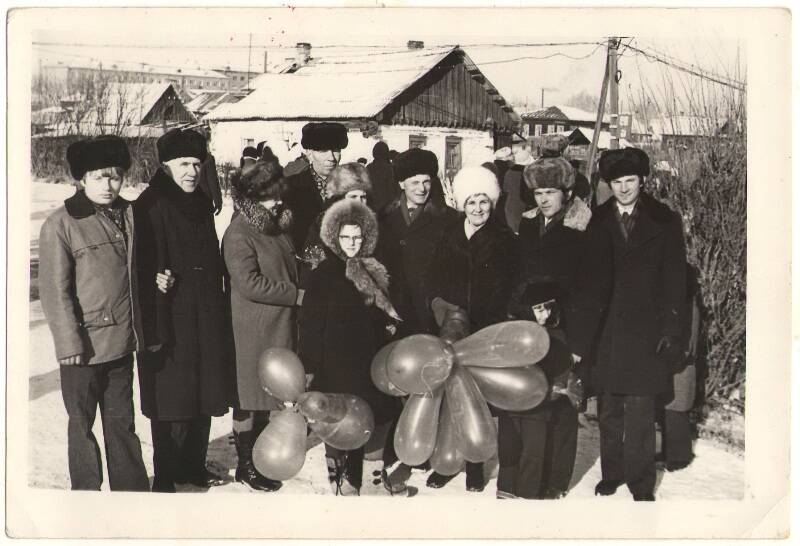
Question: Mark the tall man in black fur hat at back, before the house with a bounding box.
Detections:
[284,122,347,249]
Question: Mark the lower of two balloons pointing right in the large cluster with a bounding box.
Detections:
[469,364,548,411]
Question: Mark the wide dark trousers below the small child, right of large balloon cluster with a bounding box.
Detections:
[497,398,578,499]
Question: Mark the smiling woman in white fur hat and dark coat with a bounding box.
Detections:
[428,167,517,491]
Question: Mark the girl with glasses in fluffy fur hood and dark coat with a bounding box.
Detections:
[299,199,400,495]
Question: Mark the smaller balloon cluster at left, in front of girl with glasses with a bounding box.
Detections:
[253,348,375,480]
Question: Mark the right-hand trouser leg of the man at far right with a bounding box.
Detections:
[624,395,656,495]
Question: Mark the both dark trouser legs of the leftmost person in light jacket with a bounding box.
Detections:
[59,355,150,491]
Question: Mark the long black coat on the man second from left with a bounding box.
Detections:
[134,169,233,420]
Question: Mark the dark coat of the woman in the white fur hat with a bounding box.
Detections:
[427,214,517,332]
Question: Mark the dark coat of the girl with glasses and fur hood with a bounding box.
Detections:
[299,253,399,423]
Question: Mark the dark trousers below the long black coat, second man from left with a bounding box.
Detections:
[150,416,211,487]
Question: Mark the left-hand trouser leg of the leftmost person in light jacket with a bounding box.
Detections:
[59,365,103,491]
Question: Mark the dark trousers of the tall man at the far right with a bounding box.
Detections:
[597,392,656,495]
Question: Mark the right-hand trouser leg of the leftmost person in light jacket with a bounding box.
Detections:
[100,355,150,491]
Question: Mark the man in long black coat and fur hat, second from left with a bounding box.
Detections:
[135,129,232,492]
